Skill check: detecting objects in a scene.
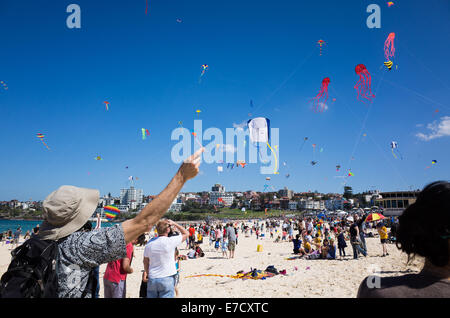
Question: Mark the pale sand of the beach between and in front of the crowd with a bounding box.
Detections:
[0,226,423,298]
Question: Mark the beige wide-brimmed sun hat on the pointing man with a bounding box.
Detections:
[39,185,100,241]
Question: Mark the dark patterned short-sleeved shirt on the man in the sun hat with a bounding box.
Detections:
[57,224,127,298]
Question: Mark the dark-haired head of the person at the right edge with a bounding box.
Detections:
[396,181,450,266]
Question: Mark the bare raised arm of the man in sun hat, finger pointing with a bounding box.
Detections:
[122,148,204,244]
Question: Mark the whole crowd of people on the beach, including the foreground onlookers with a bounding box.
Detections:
[0,148,450,298]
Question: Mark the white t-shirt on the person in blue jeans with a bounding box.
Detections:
[144,235,182,278]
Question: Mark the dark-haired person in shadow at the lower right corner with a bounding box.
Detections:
[357,181,450,299]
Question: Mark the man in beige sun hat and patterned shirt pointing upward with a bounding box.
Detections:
[38,148,204,298]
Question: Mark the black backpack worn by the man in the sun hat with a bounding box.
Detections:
[0,236,98,298]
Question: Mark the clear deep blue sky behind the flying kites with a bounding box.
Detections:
[0,0,450,200]
